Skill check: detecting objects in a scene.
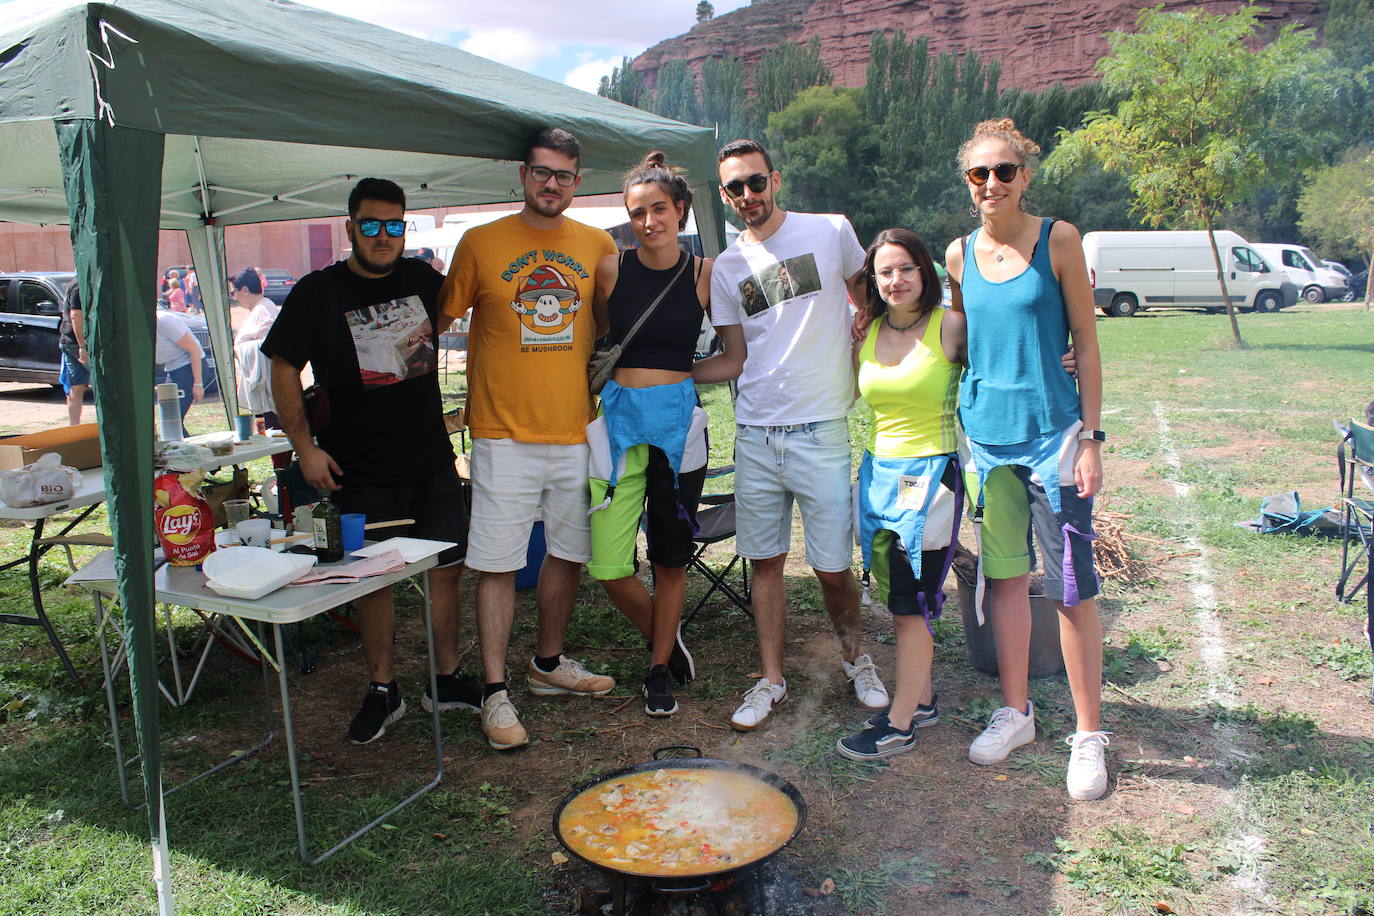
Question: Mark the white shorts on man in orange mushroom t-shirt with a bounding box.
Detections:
[467,439,592,573]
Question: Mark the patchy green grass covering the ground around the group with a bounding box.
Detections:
[0,309,1374,916]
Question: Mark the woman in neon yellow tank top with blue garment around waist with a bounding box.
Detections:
[835,229,966,759]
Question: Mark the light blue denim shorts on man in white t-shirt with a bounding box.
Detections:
[735,417,855,573]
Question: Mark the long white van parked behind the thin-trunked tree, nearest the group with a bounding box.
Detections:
[1083,229,1298,317]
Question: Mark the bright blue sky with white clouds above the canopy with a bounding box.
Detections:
[0,0,749,92]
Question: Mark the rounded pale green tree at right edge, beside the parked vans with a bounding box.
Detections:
[1297,148,1374,310]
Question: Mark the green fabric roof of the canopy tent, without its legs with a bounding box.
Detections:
[0,0,720,246]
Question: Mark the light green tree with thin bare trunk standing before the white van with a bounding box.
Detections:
[1046,5,1337,346]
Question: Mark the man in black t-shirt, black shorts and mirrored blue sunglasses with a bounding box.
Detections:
[262,179,482,744]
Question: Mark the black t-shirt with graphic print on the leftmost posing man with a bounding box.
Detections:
[262,258,453,486]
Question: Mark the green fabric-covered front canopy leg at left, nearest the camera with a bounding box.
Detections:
[54,114,173,916]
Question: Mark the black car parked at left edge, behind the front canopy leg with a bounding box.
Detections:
[0,271,220,397]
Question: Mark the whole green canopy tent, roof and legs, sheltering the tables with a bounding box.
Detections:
[0,0,723,912]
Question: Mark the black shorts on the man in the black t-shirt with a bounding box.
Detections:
[330,464,467,566]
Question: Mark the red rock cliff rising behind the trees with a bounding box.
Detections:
[633,0,1320,89]
